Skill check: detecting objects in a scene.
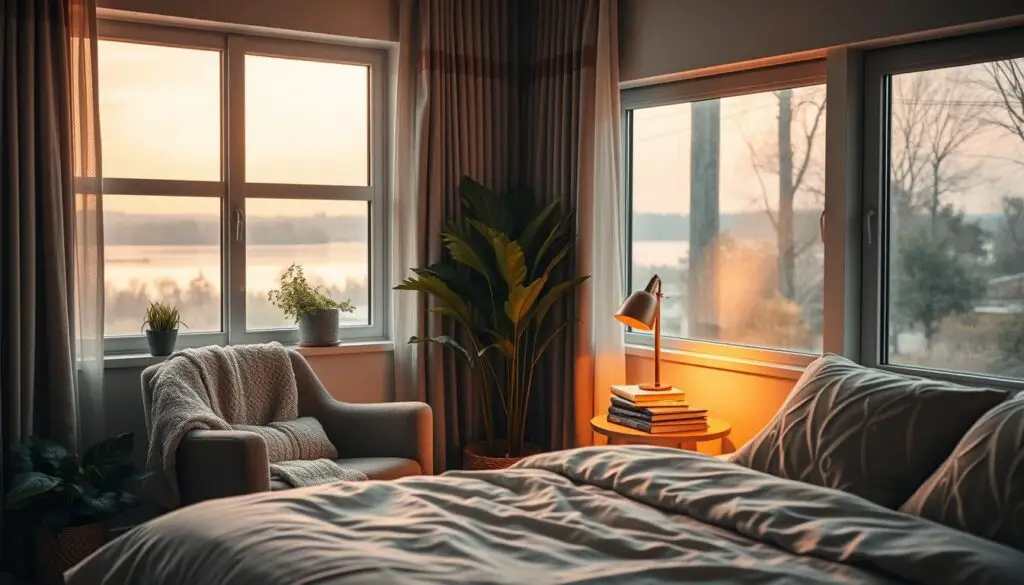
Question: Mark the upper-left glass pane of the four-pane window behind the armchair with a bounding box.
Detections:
[98,41,220,180]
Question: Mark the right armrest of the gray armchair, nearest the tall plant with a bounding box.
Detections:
[317,400,434,475]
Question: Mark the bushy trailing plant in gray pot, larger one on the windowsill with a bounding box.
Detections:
[266,264,355,346]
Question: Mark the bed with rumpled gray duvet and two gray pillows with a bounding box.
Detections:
[66,357,1024,585]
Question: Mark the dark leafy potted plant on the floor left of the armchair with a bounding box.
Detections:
[6,432,152,583]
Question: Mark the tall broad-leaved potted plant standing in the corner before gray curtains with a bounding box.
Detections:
[395,177,589,469]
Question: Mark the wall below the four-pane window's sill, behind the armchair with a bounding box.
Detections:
[103,350,394,463]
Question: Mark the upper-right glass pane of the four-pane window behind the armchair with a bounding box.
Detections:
[246,55,370,185]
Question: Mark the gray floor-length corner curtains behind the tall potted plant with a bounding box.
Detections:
[393,0,617,470]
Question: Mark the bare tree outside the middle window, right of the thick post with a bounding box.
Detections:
[746,89,825,300]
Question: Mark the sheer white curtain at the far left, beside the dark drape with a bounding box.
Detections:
[68,0,106,448]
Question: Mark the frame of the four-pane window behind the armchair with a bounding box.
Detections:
[98,18,390,354]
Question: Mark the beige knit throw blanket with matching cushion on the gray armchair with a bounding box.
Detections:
[143,342,366,506]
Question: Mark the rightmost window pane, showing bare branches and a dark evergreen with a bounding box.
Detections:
[886,59,1024,377]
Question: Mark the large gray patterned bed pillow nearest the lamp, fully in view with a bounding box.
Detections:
[732,356,1007,508]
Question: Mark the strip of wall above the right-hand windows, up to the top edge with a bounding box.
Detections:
[618,0,1024,82]
